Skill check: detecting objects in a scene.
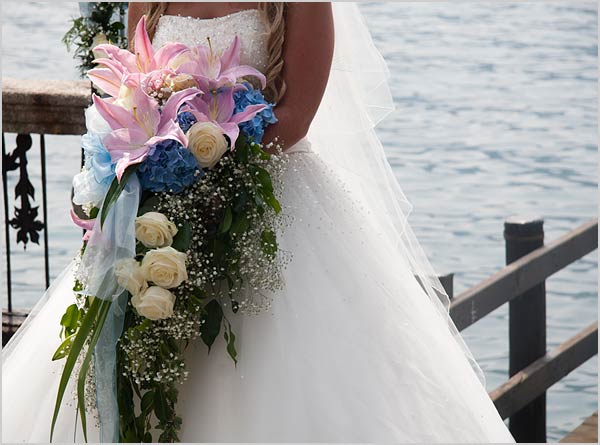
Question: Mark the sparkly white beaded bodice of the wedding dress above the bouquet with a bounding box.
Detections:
[152,9,269,72]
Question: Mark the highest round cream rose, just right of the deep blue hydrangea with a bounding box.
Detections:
[187,122,227,168]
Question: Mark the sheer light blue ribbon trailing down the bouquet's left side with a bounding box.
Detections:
[82,174,141,443]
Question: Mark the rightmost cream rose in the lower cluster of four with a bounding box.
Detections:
[142,247,187,289]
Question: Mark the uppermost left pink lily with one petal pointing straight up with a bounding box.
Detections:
[88,16,189,97]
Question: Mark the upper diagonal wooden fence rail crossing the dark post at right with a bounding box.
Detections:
[450,218,598,330]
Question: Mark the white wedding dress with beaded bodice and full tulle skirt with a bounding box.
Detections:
[2,5,514,443]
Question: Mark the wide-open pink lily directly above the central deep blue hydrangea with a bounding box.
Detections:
[93,88,202,180]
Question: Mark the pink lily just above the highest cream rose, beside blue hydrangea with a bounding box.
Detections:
[181,88,266,147]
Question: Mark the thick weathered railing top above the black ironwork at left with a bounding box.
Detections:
[2,78,92,134]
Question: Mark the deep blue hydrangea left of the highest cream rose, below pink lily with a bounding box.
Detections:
[137,139,204,193]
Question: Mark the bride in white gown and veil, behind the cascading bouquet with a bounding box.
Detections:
[2,2,514,443]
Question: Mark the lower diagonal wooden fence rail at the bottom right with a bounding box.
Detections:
[489,321,598,419]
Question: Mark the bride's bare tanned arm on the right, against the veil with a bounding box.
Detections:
[263,3,333,149]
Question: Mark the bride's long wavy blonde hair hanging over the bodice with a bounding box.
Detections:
[146,2,286,102]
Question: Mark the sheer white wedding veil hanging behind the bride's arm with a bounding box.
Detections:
[308,2,485,387]
